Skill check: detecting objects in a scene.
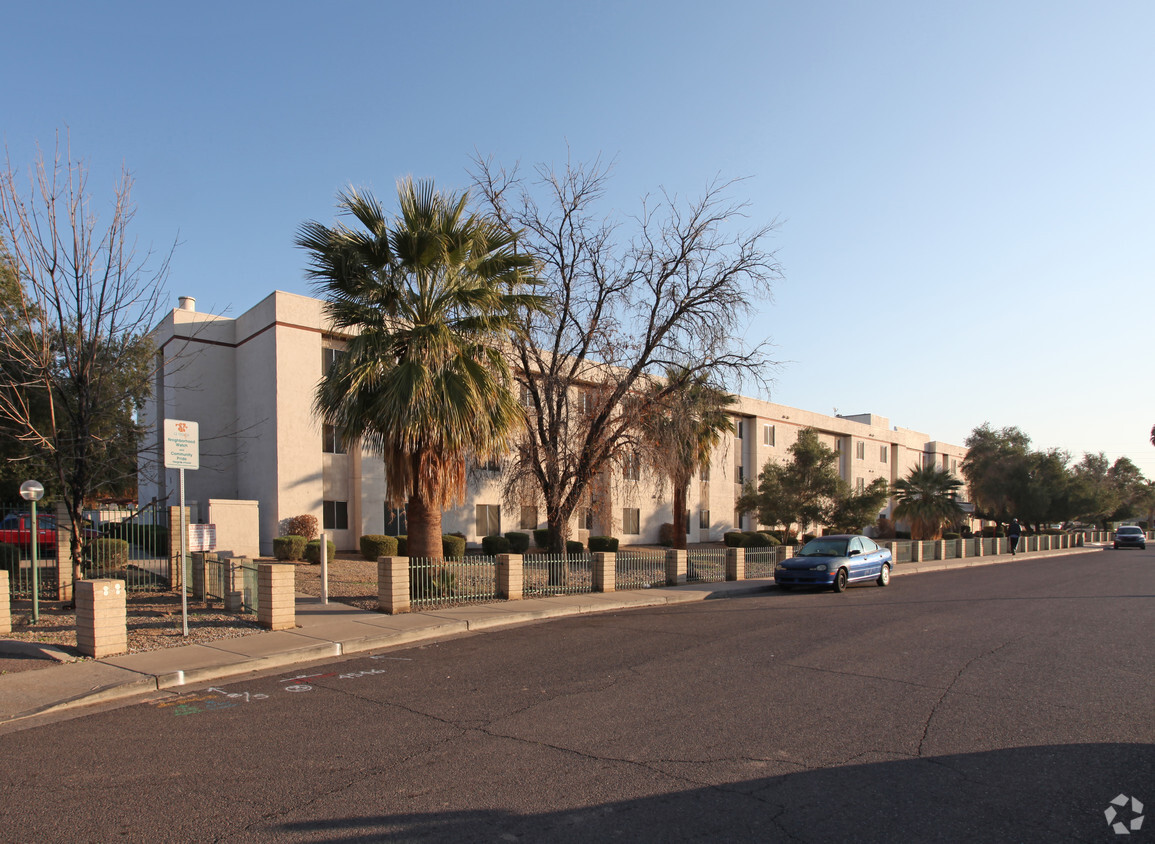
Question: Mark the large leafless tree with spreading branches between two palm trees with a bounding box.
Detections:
[474,159,781,553]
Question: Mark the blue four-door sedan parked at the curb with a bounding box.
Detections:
[774,536,893,592]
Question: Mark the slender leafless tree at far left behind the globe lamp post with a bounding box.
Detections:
[0,143,171,580]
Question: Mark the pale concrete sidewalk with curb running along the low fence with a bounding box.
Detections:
[0,546,1101,725]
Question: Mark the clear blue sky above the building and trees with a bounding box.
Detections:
[0,0,1155,478]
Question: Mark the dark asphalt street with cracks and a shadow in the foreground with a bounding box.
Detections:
[0,548,1155,842]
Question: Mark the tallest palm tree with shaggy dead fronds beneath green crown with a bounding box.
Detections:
[297,179,545,558]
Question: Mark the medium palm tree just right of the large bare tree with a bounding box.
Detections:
[642,367,738,550]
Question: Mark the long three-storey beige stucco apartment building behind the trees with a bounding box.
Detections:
[140,291,966,554]
